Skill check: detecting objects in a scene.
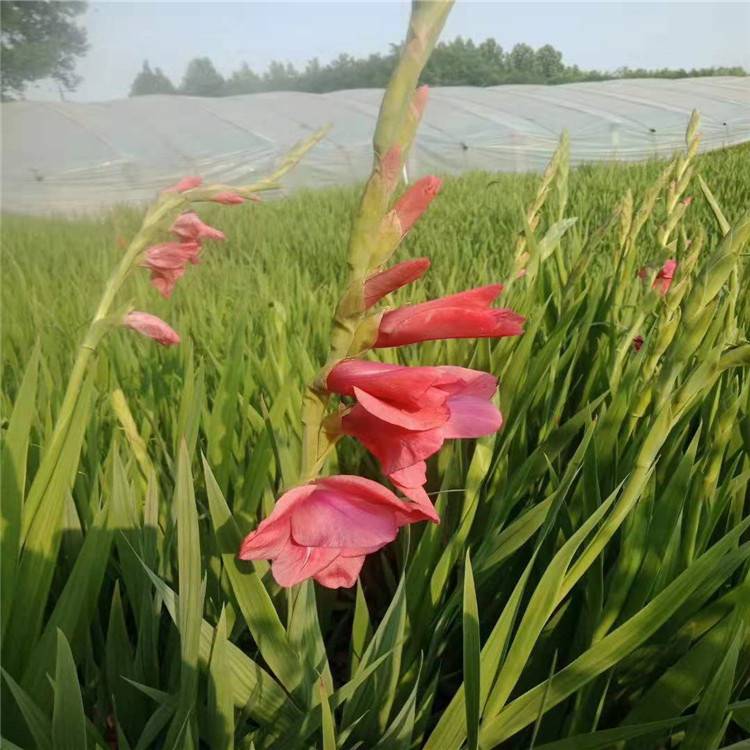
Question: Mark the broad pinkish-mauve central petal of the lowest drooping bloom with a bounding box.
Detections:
[291,488,398,549]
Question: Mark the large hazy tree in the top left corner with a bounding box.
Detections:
[0,0,88,99]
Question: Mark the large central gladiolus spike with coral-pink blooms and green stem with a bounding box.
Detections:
[238,53,524,588]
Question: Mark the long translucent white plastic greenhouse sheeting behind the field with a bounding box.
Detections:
[2,77,750,213]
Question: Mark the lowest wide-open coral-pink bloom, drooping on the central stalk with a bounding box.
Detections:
[239,475,438,589]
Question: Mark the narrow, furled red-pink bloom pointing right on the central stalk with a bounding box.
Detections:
[375,284,526,348]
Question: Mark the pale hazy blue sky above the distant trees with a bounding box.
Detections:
[23,0,750,101]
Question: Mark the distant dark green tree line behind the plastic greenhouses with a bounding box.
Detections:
[130,36,746,96]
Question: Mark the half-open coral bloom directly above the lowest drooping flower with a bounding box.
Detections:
[327,359,503,503]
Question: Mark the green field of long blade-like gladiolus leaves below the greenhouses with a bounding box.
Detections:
[2,135,750,750]
